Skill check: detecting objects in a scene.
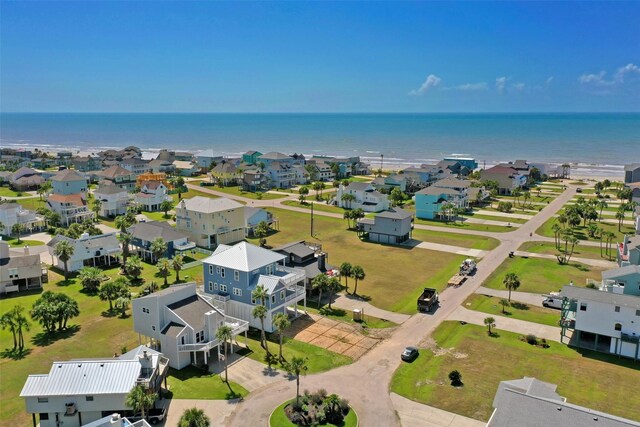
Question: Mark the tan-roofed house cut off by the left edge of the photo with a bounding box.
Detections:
[0,240,47,294]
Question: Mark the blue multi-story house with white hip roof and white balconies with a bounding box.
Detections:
[202,242,307,332]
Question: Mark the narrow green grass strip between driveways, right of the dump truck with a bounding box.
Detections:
[463,294,560,327]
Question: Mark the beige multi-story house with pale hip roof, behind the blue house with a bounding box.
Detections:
[175,196,244,249]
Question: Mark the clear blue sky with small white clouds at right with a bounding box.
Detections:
[0,1,640,112]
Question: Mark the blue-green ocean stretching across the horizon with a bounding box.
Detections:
[0,113,640,176]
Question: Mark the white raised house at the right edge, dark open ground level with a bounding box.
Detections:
[561,265,640,360]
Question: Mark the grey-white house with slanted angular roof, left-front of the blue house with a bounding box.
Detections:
[132,283,249,369]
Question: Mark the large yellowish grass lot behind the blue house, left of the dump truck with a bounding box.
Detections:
[249,208,464,314]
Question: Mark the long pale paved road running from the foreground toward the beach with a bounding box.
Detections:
[228,186,575,426]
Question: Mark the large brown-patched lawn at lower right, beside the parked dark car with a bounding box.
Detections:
[390,322,640,421]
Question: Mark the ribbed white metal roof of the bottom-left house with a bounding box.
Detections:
[20,359,141,397]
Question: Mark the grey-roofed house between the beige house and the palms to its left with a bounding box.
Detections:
[128,221,196,261]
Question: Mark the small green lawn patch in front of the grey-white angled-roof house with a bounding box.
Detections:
[167,366,249,400]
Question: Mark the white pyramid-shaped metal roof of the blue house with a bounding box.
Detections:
[202,242,286,272]
